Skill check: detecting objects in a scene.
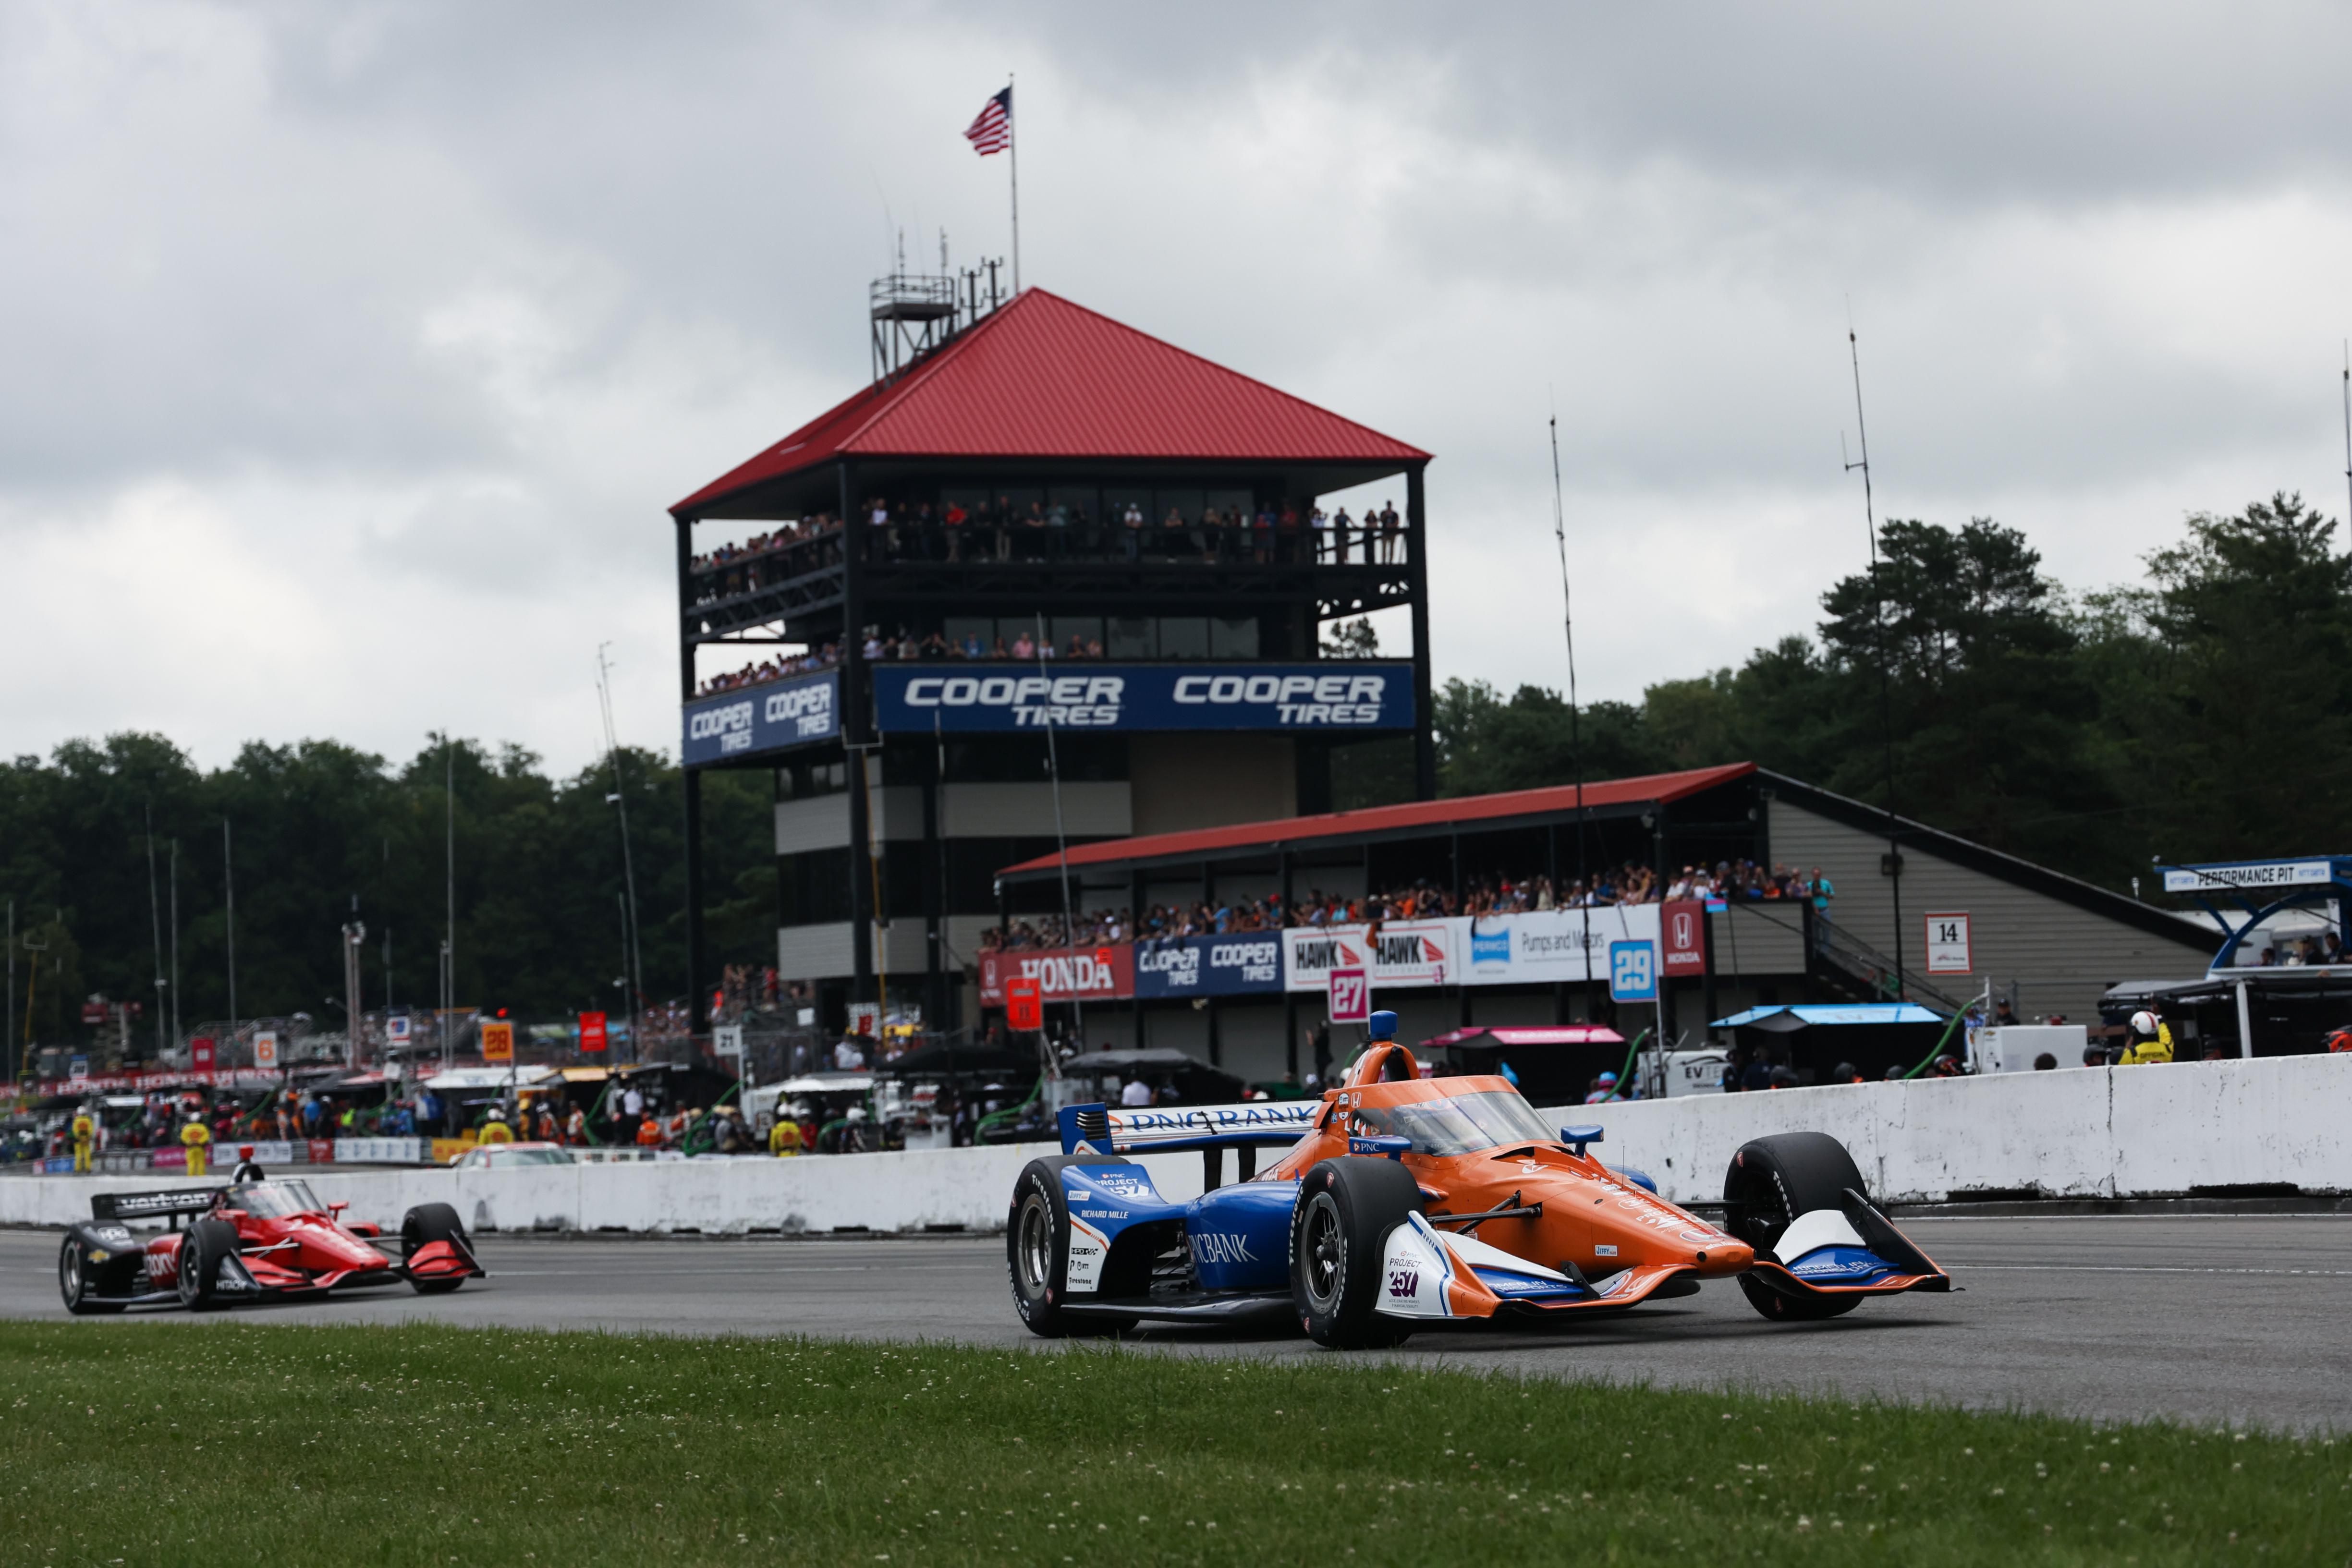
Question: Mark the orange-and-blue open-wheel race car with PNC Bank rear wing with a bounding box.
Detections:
[1004,1013,1952,1349]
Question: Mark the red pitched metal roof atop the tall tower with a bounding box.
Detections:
[670,289,1430,512]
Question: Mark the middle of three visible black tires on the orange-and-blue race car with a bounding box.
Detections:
[1291,1156,1421,1349]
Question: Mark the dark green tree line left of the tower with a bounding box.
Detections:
[0,733,776,1044]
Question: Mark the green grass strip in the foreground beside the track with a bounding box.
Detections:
[0,1324,2352,1568]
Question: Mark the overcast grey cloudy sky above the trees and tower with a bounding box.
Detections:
[0,0,2352,769]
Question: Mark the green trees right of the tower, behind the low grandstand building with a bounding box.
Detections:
[1385,494,2352,891]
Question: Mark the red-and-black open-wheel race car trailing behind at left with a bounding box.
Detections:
[57,1180,485,1314]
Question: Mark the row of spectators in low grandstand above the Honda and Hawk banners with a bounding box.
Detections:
[981,861,1835,952]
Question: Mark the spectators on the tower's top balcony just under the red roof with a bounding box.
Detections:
[687,491,1406,592]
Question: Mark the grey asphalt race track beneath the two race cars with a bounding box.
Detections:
[0,1216,2352,1432]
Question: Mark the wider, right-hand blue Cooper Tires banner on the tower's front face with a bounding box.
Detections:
[873,661,1414,733]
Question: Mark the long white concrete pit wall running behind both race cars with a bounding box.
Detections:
[0,1056,2352,1232]
